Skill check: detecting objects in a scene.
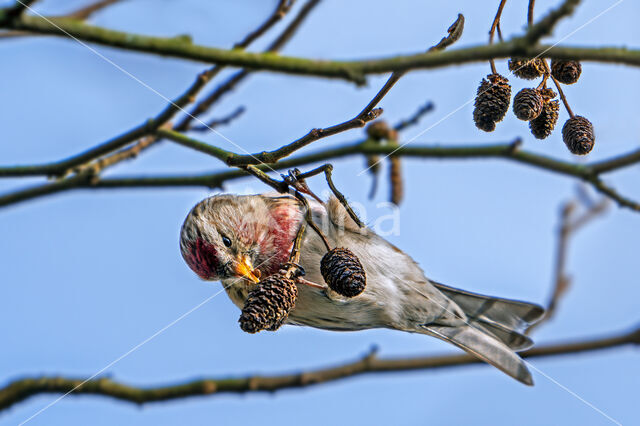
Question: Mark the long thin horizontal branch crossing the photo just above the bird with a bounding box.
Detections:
[0,138,640,208]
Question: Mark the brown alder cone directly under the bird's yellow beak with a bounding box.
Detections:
[238,273,298,333]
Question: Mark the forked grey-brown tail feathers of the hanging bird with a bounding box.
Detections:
[421,282,544,385]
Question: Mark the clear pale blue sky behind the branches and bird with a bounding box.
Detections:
[0,0,640,425]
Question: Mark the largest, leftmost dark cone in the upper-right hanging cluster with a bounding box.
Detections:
[473,73,511,132]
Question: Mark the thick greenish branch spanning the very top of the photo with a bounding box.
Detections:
[0,1,640,84]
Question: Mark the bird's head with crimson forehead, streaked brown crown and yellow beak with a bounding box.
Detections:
[180,195,301,282]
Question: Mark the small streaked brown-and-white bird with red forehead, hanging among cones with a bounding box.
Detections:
[180,194,544,385]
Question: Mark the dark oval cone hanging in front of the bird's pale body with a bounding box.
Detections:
[320,247,367,297]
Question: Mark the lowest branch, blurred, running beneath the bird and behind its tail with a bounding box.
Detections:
[0,328,640,410]
